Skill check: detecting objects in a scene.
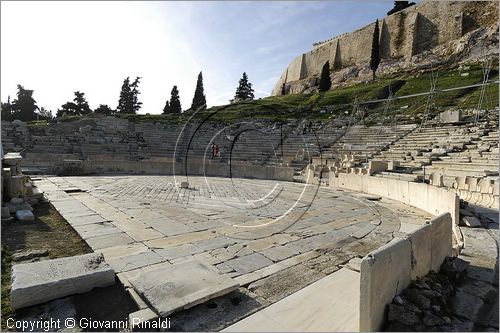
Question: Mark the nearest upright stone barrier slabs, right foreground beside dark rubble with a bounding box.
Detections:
[359,213,452,332]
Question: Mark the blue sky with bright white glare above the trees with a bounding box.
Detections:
[1,1,393,114]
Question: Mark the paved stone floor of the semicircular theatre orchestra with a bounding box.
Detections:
[36,176,431,330]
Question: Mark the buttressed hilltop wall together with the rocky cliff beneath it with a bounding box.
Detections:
[273,1,498,95]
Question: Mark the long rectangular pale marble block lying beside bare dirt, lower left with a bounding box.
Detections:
[10,253,115,309]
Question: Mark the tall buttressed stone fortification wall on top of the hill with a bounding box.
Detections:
[273,1,498,95]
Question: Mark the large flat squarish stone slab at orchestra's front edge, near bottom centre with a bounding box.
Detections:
[130,260,238,317]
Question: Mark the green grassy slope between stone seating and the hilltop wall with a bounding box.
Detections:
[48,61,498,124]
